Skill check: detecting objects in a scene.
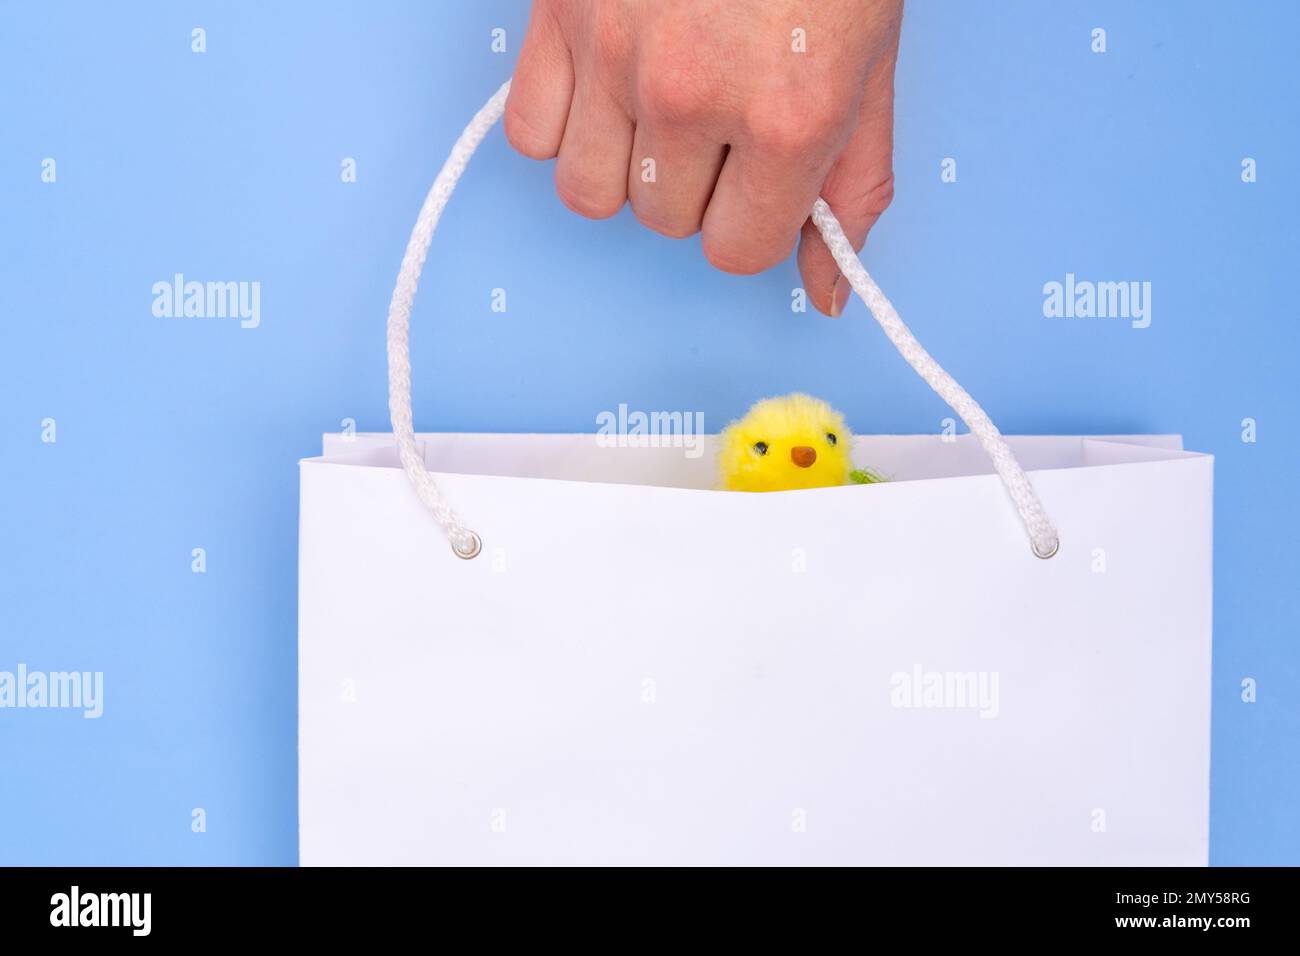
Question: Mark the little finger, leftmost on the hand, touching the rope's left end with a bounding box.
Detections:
[506,4,573,160]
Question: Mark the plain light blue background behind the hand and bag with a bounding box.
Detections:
[0,0,1300,864]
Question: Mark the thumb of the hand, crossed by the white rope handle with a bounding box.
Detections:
[798,47,897,316]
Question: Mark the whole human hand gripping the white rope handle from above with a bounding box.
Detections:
[506,0,902,315]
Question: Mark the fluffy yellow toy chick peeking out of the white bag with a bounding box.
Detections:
[718,393,884,492]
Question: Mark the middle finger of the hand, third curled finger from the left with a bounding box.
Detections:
[628,117,725,239]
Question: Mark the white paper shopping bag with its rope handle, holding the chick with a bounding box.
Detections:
[299,87,1213,865]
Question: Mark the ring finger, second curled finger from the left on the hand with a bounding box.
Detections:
[555,82,633,219]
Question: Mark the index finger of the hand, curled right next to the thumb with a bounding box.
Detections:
[703,104,846,274]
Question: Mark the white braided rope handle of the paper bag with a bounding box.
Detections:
[389,81,1060,558]
